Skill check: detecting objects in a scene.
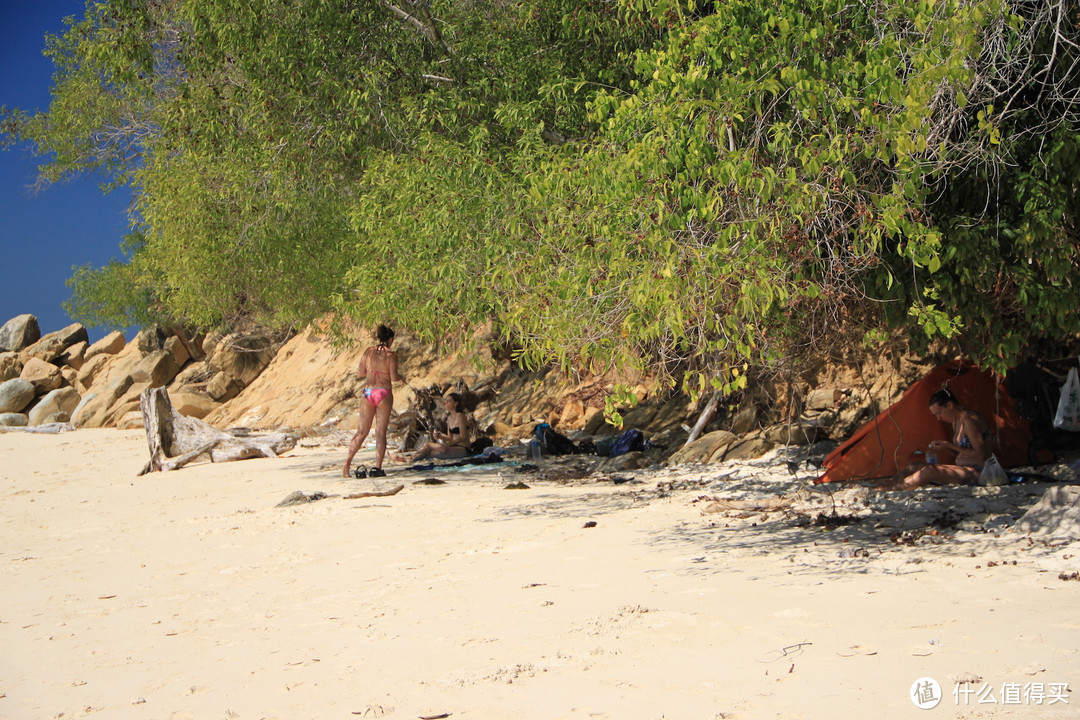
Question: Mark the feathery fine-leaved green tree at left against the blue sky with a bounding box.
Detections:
[17,0,654,326]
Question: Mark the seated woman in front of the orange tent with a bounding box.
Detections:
[900,390,993,490]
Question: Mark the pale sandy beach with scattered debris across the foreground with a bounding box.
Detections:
[0,430,1080,720]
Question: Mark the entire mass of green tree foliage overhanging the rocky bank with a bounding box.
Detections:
[3,0,1080,390]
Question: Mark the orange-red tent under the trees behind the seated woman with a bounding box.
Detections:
[815,361,1030,483]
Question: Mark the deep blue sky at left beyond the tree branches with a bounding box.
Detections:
[0,0,131,340]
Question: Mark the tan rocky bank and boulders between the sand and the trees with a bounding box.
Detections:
[0,315,946,470]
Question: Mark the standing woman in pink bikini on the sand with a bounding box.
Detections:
[341,325,401,477]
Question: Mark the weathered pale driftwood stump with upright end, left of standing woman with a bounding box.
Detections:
[139,388,297,475]
